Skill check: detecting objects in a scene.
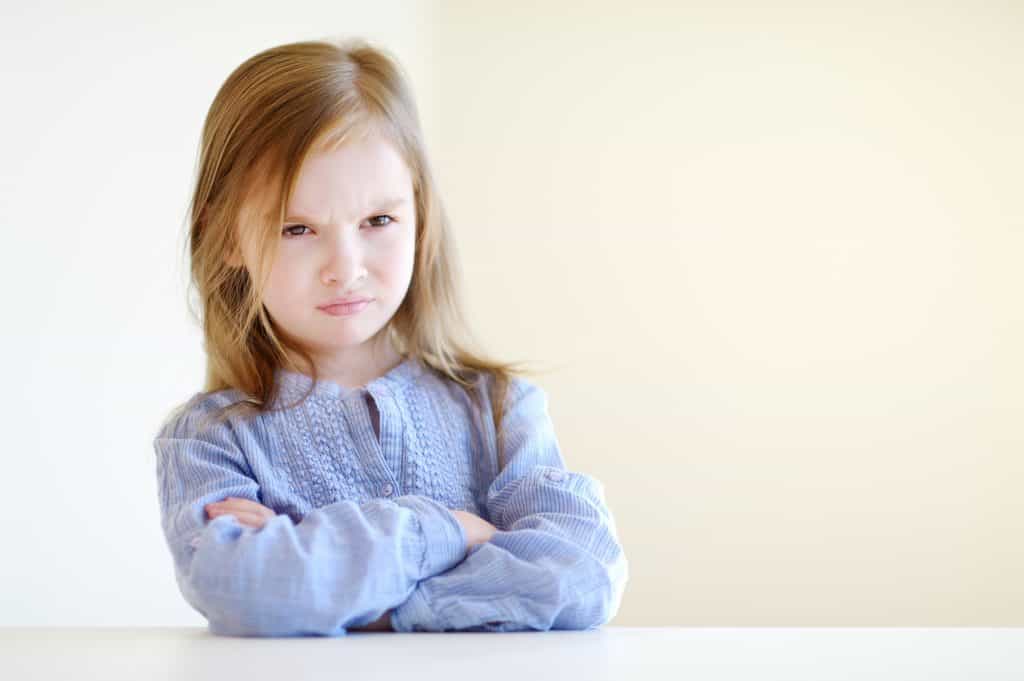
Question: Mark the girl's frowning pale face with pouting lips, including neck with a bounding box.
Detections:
[237,130,416,381]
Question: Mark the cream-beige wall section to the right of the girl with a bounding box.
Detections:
[428,2,1024,626]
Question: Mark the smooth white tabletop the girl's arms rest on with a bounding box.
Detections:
[0,627,1024,681]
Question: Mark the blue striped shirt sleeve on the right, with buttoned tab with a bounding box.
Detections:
[391,379,629,632]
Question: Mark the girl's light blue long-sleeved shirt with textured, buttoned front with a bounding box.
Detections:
[154,358,628,636]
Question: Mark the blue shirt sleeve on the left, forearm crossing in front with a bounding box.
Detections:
[154,393,467,637]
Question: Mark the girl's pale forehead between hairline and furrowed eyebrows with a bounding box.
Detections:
[288,135,413,219]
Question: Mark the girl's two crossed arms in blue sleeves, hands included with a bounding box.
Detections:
[175,376,628,636]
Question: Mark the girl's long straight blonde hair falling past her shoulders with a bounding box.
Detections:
[177,39,544,468]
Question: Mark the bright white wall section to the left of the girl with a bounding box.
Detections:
[0,0,436,626]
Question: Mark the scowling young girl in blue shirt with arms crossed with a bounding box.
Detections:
[154,41,628,636]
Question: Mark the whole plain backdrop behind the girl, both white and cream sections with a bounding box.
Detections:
[0,0,1024,626]
